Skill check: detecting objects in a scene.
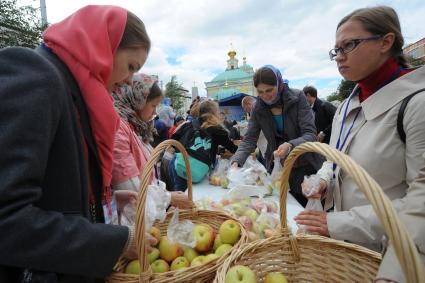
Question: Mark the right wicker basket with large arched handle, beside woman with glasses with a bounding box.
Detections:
[214,143,425,283]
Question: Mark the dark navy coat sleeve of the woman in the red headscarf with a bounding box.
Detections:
[0,48,129,277]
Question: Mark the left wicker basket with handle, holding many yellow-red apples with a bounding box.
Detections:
[106,140,248,283]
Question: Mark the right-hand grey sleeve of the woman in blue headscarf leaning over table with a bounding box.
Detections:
[289,91,317,147]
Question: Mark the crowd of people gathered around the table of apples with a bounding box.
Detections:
[0,2,425,282]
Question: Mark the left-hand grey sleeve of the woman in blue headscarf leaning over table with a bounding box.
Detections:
[230,108,261,166]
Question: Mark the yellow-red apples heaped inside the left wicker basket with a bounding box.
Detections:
[124,220,241,274]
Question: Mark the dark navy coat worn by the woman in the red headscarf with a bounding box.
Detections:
[0,48,128,283]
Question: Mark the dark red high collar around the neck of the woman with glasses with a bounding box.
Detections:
[358,57,409,102]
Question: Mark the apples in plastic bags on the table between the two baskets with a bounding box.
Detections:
[196,196,280,241]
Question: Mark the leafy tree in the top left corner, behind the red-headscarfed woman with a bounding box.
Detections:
[0,0,45,48]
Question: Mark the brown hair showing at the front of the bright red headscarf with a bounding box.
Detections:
[118,11,151,53]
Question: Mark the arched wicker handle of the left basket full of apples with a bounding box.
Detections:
[135,139,193,282]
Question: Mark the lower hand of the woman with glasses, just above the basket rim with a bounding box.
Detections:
[294,210,329,237]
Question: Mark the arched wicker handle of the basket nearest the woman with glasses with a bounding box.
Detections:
[280,142,425,282]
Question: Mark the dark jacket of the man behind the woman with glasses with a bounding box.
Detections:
[312,98,336,144]
